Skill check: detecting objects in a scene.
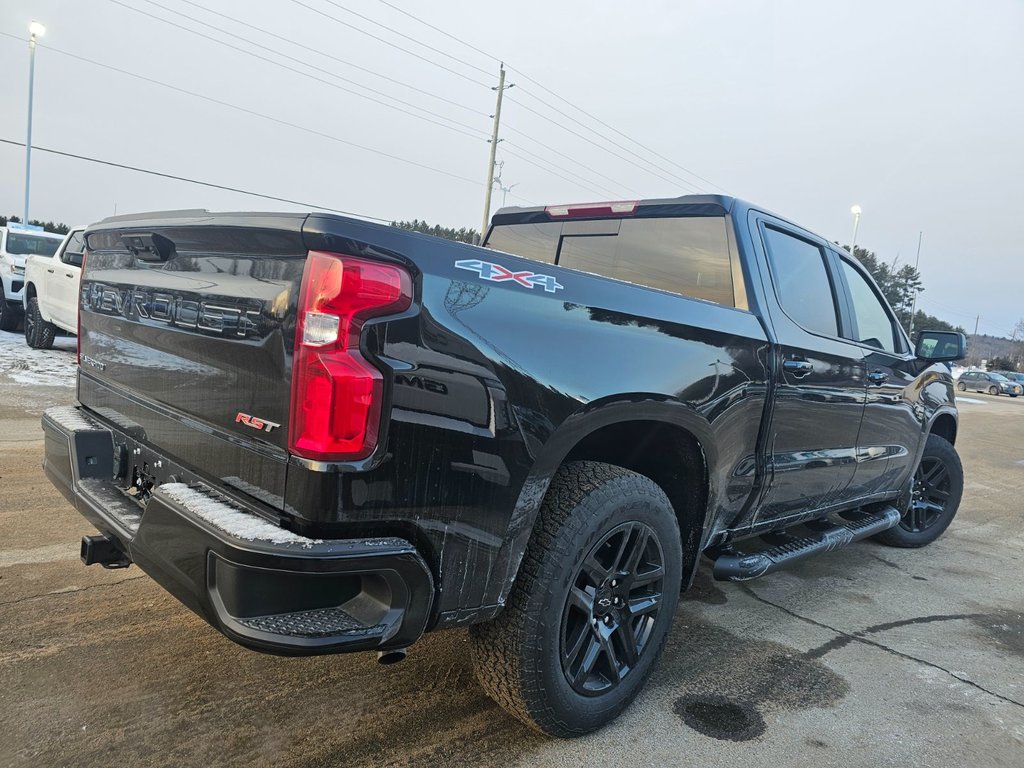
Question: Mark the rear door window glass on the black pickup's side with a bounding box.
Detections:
[765,226,839,336]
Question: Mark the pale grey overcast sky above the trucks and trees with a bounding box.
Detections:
[0,0,1024,335]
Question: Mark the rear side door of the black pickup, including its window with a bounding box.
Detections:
[751,213,864,524]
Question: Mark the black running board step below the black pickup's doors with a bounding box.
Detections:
[712,507,900,582]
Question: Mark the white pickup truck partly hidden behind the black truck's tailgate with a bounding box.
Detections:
[23,226,85,349]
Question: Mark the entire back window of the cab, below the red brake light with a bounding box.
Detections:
[486,216,745,306]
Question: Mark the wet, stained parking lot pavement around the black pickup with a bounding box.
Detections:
[0,332,1024,768]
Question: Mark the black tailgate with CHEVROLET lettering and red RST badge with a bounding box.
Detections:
[79,212,306,509]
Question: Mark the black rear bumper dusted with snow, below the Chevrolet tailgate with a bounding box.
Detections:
[43,408,433,655]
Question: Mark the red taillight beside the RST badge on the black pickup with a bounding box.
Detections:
[289,251,413,461]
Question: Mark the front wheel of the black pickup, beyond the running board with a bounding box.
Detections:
[874,434,964,548]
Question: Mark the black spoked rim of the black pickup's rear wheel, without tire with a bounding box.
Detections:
[560,521,665,696]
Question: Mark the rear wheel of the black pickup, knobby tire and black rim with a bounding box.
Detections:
[470,462,682,736]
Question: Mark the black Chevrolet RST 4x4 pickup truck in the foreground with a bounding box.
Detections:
[43,196,965,736]
